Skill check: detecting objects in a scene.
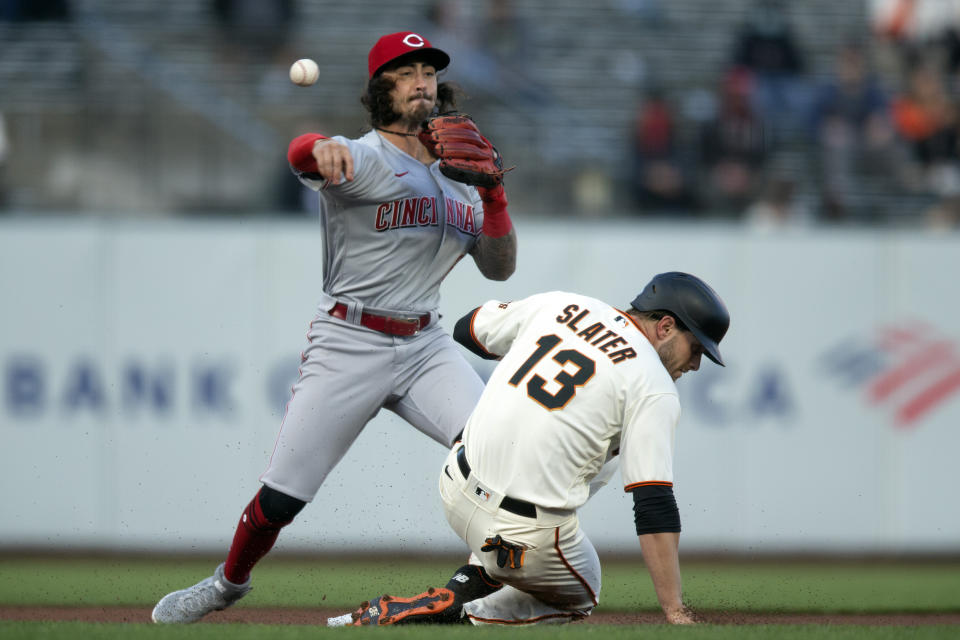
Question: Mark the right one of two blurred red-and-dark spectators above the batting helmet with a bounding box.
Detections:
[699,71,768,213]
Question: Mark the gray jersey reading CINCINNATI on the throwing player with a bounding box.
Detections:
[300,131,483,313]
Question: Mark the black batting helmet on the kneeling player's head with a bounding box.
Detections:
[630,271,730,367]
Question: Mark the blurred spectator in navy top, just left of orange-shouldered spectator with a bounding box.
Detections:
[811,42,903,219]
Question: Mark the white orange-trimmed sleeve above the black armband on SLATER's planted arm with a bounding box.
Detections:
[620,393,680,491]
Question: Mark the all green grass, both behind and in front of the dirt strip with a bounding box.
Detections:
[0,555,960,640]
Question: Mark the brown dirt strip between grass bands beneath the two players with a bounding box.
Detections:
[0,606,960,626]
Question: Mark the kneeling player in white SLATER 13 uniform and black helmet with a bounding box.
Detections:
[328,272,730,626]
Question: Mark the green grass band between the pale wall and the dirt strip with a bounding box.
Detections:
[0,556,960,613]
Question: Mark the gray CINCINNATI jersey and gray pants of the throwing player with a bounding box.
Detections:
[260,132,483,501]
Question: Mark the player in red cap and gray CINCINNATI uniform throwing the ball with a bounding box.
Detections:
[152,32,517,623]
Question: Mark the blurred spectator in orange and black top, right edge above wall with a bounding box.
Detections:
[893,64,960,196]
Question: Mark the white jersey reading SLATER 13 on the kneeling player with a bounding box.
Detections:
[463,291,680,509]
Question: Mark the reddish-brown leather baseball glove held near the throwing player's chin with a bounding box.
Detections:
[418,114,513,188]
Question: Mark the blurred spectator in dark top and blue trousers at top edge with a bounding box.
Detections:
[733,0,810,139]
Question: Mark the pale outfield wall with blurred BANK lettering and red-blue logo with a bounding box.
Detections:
[0,219,960,552]
